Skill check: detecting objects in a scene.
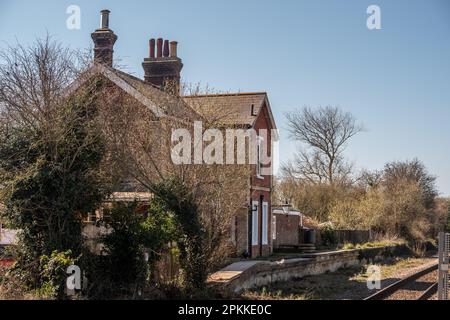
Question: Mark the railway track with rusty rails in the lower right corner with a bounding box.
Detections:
[364,264,438,300]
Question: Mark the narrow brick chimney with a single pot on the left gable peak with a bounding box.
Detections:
[91,10,117,67]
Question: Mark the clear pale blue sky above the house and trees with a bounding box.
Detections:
[0,0,450,196]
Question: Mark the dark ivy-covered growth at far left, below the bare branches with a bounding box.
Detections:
[0,80,108,288]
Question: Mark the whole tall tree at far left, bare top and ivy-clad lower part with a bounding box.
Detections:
[0,36,107,297]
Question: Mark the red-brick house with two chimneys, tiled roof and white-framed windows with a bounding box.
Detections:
[70,10,277,257]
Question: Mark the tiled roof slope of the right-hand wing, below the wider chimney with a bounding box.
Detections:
[183,92,266,126]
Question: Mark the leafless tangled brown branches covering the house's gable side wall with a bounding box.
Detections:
[94,84,250,285]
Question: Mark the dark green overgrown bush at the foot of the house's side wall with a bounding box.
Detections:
[86,199,176,298]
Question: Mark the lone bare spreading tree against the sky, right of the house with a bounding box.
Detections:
[283,106,363,184]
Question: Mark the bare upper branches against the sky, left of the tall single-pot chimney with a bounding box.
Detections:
[0,35,90,129]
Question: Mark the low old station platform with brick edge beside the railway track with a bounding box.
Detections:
[209,245,408,293]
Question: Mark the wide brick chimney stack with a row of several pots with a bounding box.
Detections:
[142,38,183,95]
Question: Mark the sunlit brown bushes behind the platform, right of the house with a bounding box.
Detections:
[275,149,442,246]
